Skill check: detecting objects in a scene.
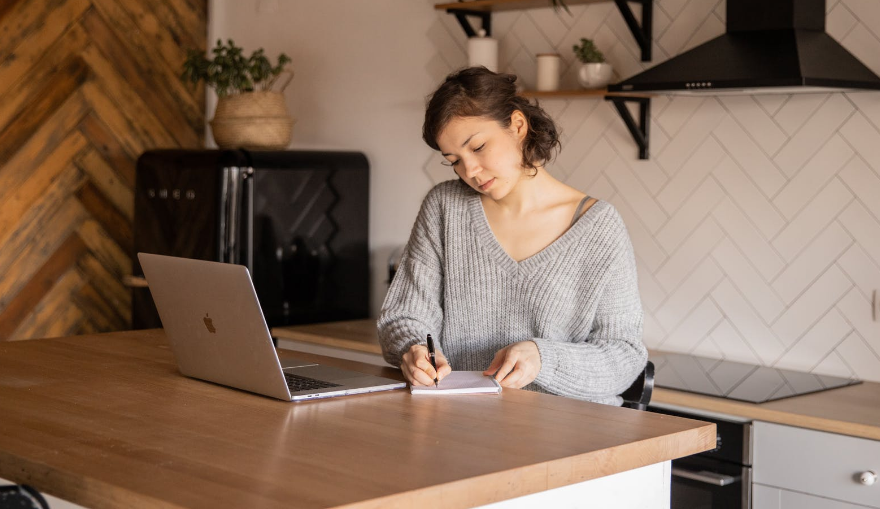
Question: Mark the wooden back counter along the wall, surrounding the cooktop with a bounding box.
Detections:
[272,320,880,440]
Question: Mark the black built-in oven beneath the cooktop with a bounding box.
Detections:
[648,405,752,509]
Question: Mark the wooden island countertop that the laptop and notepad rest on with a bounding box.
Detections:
[0,330,715,509]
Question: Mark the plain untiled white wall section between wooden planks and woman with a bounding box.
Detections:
[207,0,436,315]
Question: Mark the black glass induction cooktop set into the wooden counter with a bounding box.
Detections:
[651,352,861,403]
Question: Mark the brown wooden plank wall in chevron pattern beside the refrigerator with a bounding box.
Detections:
[0,0,207,340]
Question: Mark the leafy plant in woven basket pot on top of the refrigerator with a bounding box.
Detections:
[181,39,293,150]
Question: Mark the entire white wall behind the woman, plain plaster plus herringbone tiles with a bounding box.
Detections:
[211,0,880,381]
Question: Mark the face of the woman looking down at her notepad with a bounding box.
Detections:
[437,111,528,200]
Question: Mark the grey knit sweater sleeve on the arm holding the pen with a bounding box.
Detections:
[377,188,444,366]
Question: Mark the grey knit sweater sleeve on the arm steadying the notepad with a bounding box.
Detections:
[533,229,648,405]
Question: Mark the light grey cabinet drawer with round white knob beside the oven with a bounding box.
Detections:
[752,422,880,508]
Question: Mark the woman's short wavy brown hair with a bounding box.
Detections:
[422,66,561,171]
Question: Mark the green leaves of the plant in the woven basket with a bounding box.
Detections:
[180,39,291,97]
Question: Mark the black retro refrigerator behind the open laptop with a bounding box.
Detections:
[129,150,370,329]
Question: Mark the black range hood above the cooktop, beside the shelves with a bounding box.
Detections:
[608,0,880,95]
